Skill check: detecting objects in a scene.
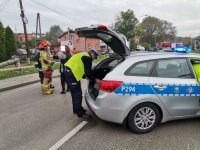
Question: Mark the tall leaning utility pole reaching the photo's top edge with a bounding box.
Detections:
[19,0,31,64]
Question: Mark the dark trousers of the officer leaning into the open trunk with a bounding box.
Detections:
[65,67,85,116]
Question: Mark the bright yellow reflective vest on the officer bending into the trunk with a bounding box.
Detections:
[65,53,90,81]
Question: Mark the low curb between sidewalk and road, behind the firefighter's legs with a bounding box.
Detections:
[0,75,60,93]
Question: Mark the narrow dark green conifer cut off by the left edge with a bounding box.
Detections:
[0,21,6,62]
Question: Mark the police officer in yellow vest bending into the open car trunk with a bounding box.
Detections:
[65,49,99,118]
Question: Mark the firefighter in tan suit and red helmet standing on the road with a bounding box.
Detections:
[38,40,54,94]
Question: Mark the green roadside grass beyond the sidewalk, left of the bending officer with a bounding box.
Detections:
[0,64,60,80]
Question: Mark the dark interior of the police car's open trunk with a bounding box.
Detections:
[88,54,124,100]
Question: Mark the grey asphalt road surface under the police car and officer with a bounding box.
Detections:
[0,78,200,150]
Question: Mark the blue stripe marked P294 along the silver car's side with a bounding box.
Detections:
[114,83,200,96]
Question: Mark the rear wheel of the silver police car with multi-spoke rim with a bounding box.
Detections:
[128,103,160,134]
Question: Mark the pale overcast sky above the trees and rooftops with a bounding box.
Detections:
[0,0,200,37]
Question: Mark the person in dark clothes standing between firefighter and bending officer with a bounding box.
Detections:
[58,45,72,94]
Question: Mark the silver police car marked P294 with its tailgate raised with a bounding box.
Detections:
[75,25,200,133]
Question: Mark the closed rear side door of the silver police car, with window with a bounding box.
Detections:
[149,58,200,116]
